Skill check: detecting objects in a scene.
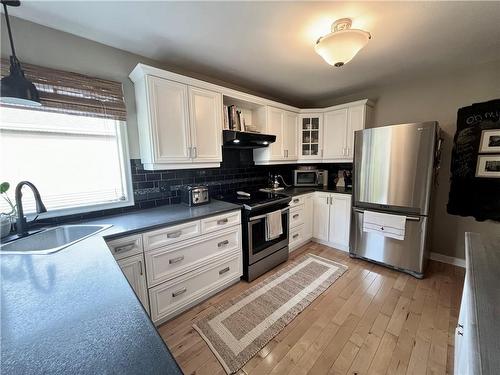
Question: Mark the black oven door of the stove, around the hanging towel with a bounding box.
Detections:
[247,207,289,264]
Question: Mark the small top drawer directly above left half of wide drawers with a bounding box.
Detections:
[144,220,201,251]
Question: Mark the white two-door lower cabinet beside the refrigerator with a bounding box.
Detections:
[313,192,351,251]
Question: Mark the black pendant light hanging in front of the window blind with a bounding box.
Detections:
[0,0,42,106]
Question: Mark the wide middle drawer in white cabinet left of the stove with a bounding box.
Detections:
[146,226,241,287]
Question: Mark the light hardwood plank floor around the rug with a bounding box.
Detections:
[159,242,464,375]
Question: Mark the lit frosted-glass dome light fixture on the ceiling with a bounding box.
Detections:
[314,18,371,68]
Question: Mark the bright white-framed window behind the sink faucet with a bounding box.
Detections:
[0,59,133,217]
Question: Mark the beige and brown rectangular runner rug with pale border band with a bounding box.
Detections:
[193,254,347,374]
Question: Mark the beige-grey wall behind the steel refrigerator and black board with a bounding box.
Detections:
[318,61,500,258]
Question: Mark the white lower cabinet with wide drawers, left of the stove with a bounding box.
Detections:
[108,210,243,325]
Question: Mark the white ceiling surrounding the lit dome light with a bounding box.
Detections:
[6,1,500,104]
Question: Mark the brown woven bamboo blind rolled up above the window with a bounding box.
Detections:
[0,59,127,121]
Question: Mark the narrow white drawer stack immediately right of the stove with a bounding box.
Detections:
[288,194,312,251]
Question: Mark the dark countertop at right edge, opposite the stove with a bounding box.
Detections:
[464,233,500,374]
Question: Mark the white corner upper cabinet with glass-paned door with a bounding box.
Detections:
[299,113,323,160]
